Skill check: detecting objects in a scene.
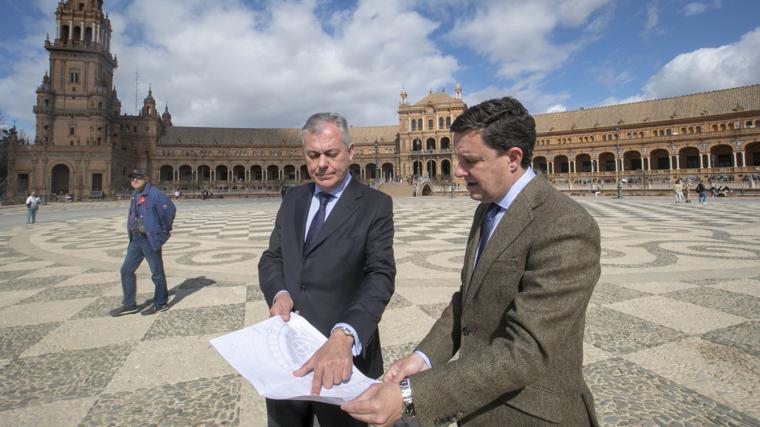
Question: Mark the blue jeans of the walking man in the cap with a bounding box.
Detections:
[121,234,169,306]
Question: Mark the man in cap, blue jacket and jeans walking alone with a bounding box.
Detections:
[111,169,177,316]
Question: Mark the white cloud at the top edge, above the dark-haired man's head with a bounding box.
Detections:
[448,0,609,79]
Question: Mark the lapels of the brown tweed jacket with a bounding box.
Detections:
[458,176,546,301]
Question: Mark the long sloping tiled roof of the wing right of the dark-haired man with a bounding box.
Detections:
[534,84,760,133]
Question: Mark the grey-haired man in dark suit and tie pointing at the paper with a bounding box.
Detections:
[259,113,396,427]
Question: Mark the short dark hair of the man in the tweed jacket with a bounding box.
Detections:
[451,96,536,167]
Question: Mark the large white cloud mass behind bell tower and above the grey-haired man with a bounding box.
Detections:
[0,0,458,135]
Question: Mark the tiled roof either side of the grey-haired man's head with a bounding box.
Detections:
[158,126,398,147]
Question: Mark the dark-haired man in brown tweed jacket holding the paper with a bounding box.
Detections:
[342,97,601,426]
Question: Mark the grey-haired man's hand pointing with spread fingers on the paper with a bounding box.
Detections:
[293,333,354,396]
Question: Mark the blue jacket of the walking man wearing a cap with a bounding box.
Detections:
[127,183,177,251]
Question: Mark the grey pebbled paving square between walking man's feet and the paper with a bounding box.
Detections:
[144,304,245,340]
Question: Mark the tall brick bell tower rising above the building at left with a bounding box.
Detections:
[34,0,121,146]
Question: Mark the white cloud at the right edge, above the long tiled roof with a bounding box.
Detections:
[644,27,760,99]
